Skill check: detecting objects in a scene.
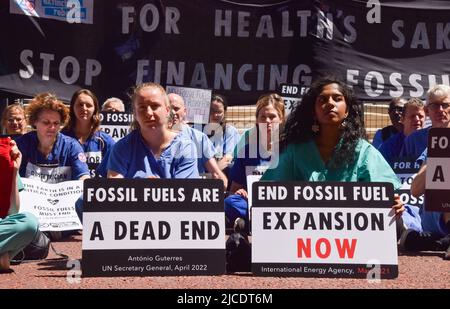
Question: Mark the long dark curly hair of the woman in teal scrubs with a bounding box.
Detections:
[281,77,366,167]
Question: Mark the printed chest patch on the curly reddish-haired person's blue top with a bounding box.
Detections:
[25,162,72,183]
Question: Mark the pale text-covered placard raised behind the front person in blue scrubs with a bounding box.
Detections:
[166,86,212,123]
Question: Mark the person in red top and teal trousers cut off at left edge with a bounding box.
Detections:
[0,138,39,272]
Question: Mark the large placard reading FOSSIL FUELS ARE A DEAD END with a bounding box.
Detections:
[83,179,225,277]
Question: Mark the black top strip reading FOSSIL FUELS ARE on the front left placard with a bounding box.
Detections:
[83,178,224,212]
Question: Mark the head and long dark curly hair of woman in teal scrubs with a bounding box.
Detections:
[282,78,366,167]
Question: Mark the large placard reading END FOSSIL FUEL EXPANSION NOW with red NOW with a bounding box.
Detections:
[252,182,398,279]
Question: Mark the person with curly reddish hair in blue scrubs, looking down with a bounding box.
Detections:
[17,93,89,183]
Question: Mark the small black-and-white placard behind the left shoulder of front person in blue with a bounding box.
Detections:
[100,112,133,142]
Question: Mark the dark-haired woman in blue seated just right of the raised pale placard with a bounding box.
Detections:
[204,94,240,170]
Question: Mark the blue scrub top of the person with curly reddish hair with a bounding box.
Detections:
[17,131,89,183]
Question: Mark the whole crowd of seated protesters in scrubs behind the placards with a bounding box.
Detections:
[0,78,450,270]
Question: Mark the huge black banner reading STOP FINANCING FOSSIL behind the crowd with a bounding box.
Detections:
[0,0,450,105]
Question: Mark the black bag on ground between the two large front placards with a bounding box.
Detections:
[225,232,252,273]
